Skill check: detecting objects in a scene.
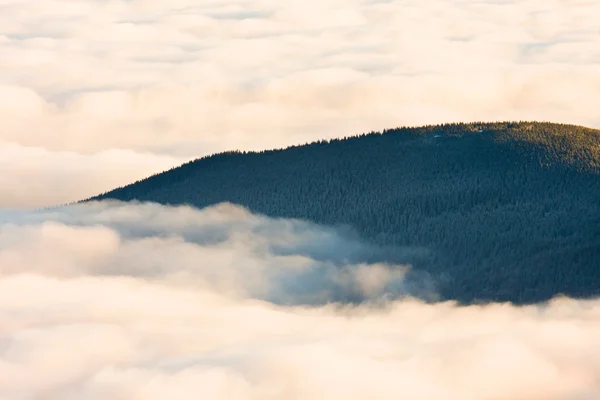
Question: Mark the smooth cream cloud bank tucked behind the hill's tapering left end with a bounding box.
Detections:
[0,144,187,208]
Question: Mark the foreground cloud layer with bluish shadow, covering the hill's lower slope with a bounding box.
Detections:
[0,203,600,400]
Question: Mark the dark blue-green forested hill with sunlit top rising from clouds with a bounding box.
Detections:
[85,122,600,303]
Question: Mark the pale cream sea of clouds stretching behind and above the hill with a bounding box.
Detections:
[0,0,600,207]
